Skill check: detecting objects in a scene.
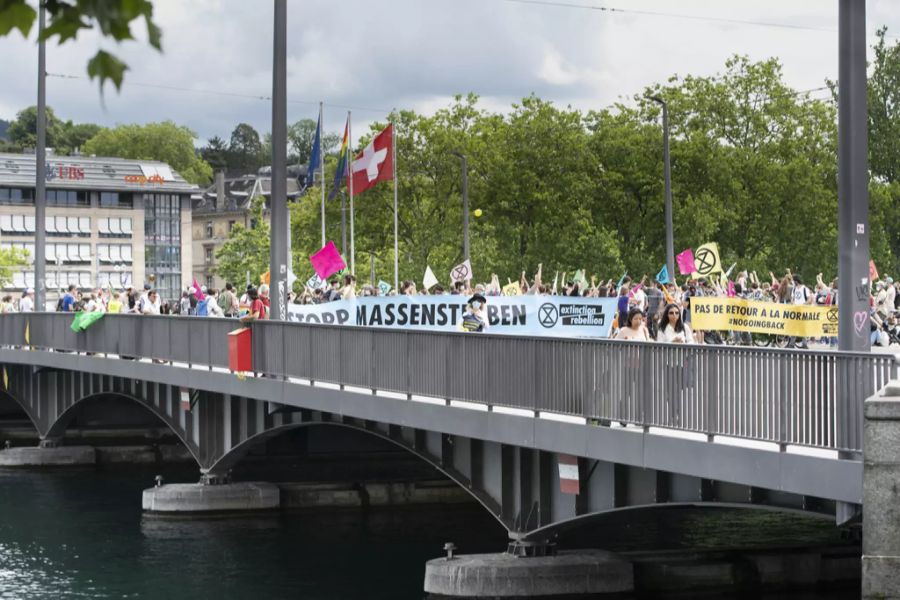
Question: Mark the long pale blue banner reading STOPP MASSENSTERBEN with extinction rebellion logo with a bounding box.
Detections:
[288,296,616,337]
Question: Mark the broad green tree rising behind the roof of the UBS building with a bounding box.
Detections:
[82,121,212,184]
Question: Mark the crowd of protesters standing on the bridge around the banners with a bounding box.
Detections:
[0,267,900,347]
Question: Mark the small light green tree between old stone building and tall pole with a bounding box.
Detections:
[216,197,269,283]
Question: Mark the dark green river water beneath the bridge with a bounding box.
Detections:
[0,468,858,600]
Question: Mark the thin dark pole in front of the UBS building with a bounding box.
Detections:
[34,2,46,312]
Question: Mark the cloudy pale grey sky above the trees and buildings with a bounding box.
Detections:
[0,0,900,143]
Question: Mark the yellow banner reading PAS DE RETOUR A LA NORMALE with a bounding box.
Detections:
[691,298,838,337]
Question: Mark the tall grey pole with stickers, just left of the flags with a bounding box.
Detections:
[269,0,290,321]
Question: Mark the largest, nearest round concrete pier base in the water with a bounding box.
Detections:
[425,550,634,598]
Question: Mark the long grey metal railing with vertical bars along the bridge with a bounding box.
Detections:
[0,313,897,452]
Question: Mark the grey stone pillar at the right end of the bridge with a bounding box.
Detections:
[862,381,900,599]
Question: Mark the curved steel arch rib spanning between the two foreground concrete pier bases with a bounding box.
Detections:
[205,421,511,531]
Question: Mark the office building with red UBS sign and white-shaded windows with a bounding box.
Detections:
[0,154,197,302]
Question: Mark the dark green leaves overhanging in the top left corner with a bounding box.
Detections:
[0,0,162,93]
